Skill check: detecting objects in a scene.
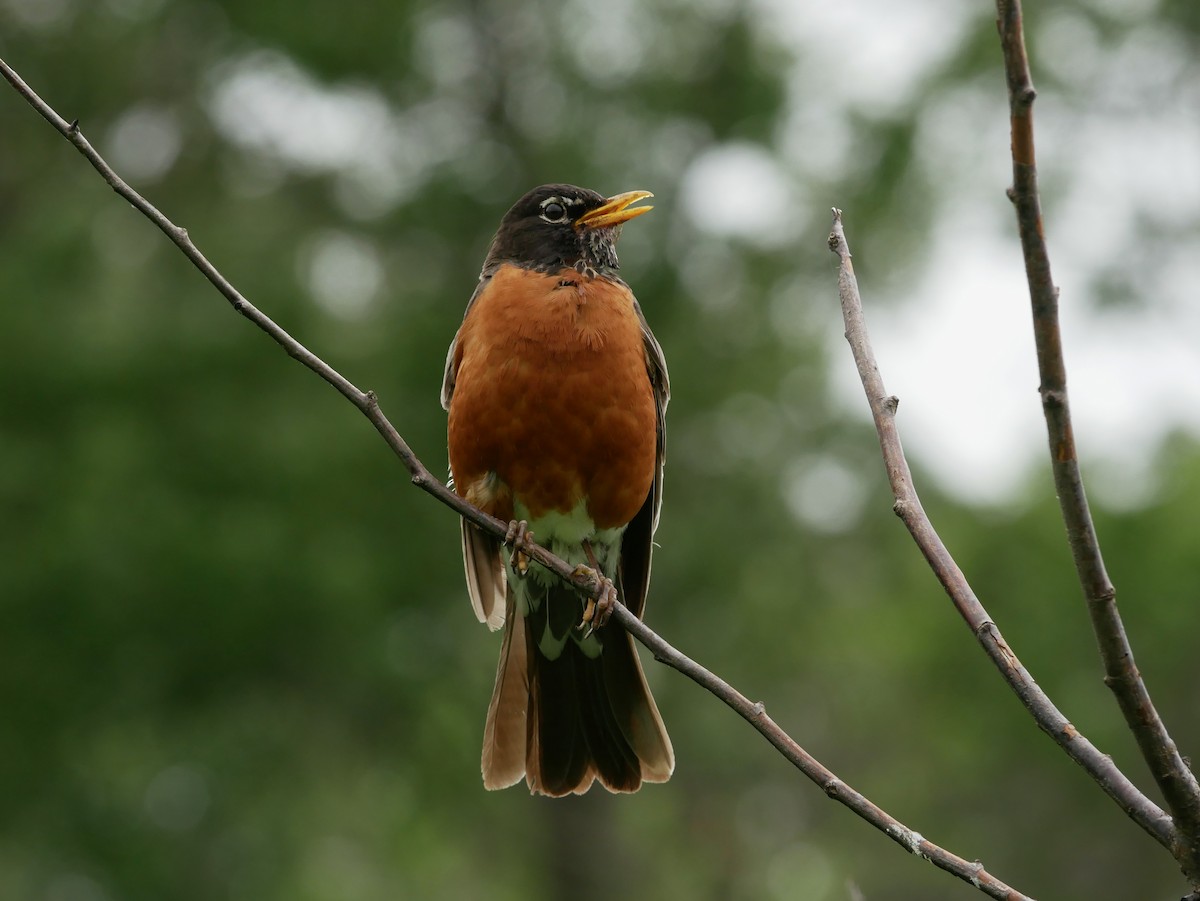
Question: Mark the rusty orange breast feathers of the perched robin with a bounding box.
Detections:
[449,265,658,529]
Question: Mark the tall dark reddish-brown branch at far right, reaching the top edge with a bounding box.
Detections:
[996,0,1200,885]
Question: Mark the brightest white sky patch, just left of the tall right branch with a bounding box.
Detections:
[829,212,1042,503]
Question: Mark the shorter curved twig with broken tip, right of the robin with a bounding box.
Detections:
[829,210,1175,848]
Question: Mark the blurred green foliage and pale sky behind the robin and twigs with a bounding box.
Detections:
[0,0,1200,901]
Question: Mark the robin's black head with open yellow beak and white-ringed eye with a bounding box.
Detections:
[484,185,654,274]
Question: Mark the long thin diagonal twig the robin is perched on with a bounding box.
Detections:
[0,60,1032,901]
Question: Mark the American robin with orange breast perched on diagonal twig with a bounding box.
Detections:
[442,185,674,797]
